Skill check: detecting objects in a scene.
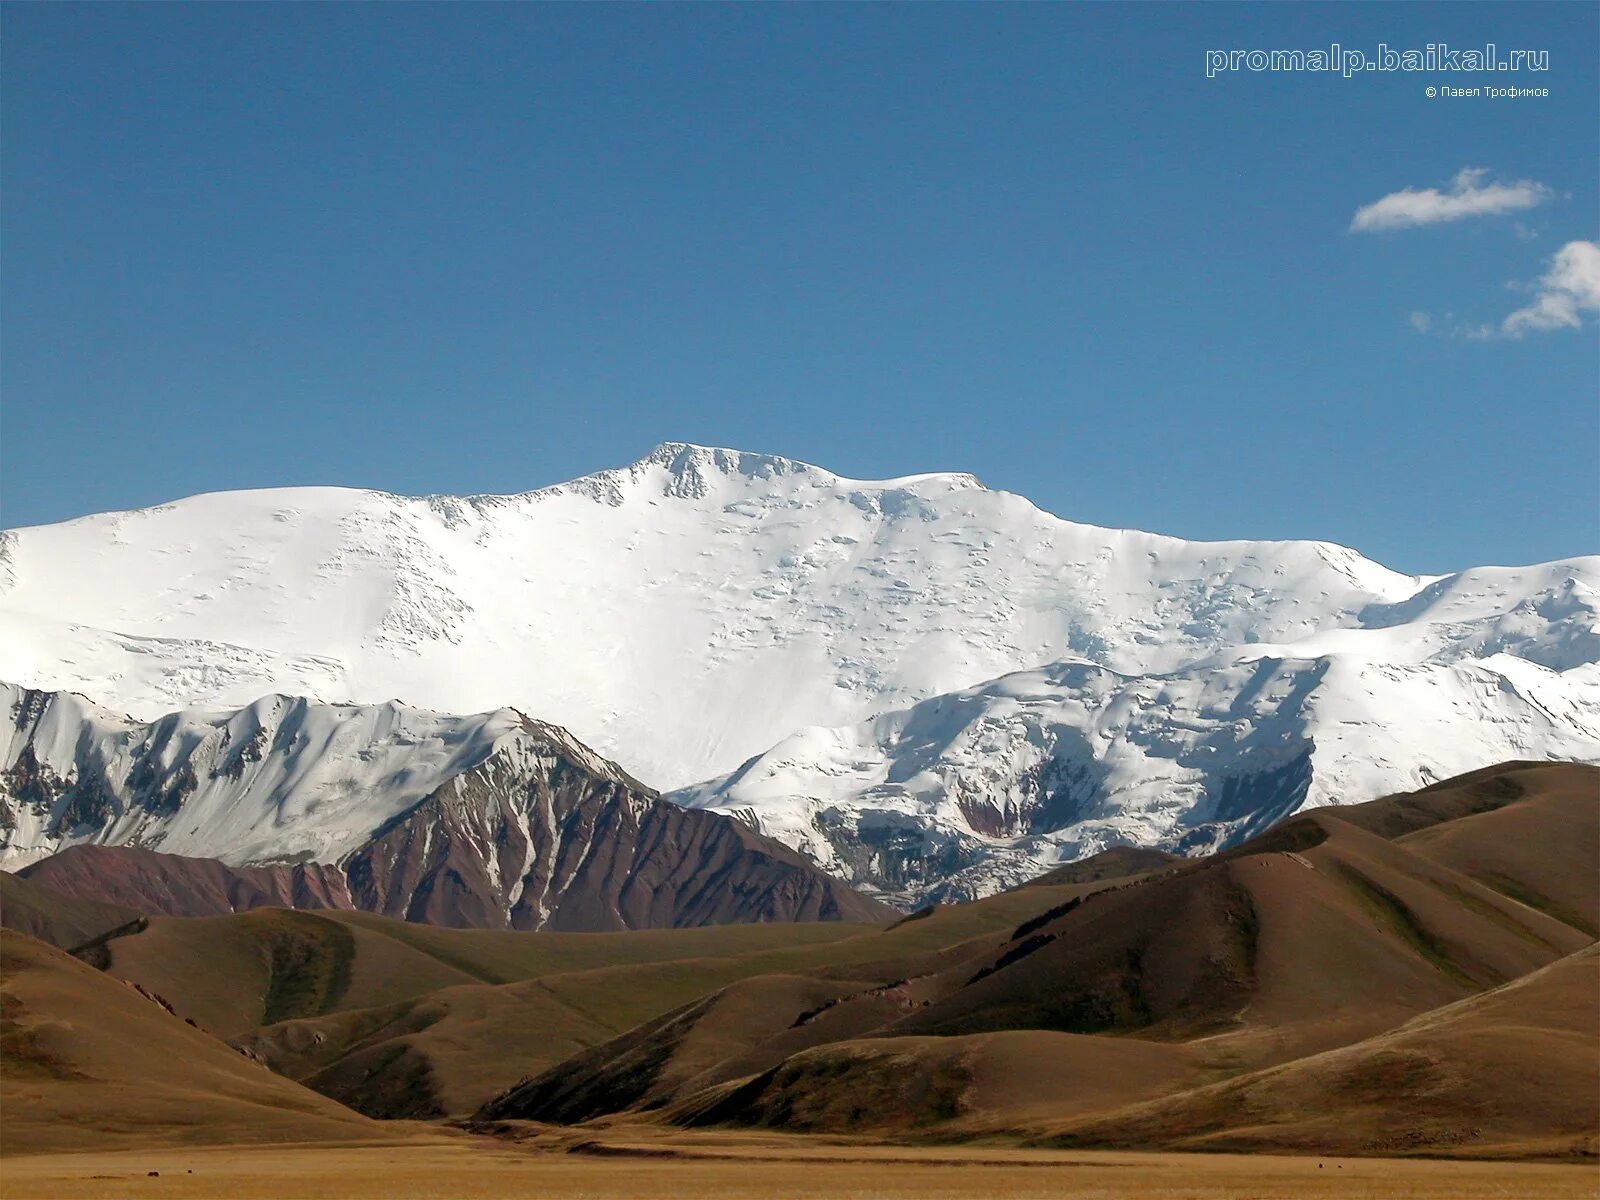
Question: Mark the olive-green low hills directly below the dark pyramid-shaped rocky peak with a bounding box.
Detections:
[14,844,1158,1117]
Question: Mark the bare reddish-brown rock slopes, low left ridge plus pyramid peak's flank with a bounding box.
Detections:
[12,790,899,931]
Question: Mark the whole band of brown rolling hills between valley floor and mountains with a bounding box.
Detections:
[3,763,1600,1157]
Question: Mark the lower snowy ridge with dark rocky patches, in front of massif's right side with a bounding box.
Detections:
[672,654,1600,906]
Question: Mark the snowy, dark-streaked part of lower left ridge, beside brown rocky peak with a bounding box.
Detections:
[0,683,553,869]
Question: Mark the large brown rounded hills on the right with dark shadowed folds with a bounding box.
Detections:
[480,765,1600,1154]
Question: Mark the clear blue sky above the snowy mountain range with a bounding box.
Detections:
[0,3,1600,571]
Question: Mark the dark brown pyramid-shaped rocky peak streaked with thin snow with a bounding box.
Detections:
[344,722,894,931]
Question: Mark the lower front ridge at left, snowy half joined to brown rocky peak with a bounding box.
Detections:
[0,685,882,930]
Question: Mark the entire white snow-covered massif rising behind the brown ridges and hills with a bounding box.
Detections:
[0,443,1600,899]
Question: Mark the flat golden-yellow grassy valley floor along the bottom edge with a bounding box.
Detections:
[0,1131,1600,1200]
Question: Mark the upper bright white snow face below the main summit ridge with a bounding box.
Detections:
[0,445,1452,787]
